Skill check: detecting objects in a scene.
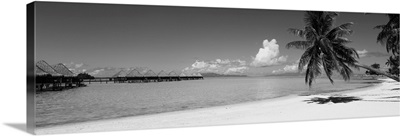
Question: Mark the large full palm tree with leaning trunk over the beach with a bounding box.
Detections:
[286,11,399,87]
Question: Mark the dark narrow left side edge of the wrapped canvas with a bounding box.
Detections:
[26,2,36,134]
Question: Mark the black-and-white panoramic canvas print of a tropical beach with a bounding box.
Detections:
[28,2,400,134]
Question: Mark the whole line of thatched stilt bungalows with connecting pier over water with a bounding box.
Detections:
[35,60,203,91]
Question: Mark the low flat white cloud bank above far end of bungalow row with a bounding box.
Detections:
[182,59,248,74]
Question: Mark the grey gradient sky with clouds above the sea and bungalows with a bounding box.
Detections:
[36,2,389,75]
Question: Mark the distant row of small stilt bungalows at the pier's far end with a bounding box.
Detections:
[113,69,203,83]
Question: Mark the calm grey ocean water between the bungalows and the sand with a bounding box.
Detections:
[36,77,378,127]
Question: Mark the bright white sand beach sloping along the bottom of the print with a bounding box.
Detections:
[36,79,400,134]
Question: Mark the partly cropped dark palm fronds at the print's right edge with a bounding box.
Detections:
[374,14,400,56]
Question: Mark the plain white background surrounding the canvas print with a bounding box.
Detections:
[0,0,400,136]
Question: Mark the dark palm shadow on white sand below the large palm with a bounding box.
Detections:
[304,96,362,104]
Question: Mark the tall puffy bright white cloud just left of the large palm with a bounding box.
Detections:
[250,39,288,67]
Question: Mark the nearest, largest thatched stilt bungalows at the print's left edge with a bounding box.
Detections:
[35,60,84,91]
